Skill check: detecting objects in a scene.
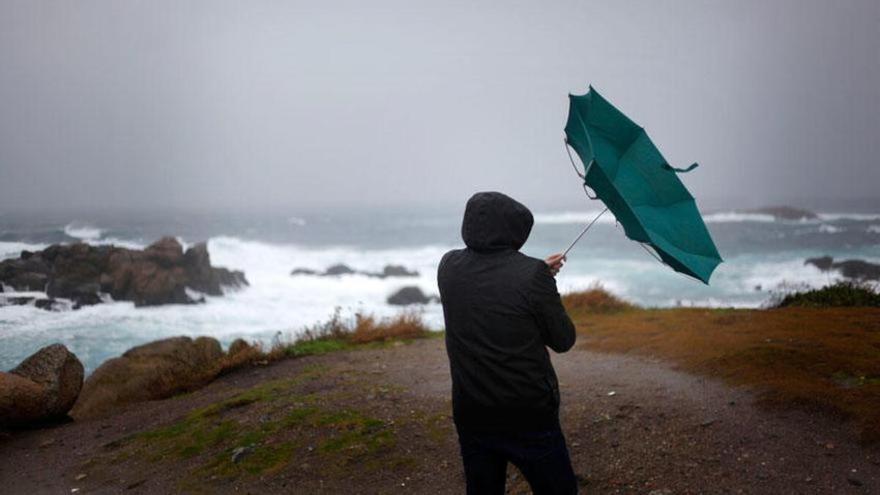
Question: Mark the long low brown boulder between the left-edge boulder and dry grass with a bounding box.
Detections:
[71,337,224,419]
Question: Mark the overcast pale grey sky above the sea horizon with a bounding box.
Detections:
[0,0,880,209]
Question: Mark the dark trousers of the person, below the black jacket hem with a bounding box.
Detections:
[458,427,578,495]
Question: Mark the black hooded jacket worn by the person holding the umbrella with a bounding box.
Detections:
[437,192,575,431]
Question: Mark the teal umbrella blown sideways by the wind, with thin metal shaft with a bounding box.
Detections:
[565,86,722,284]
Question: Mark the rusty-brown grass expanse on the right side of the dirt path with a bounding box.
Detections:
[570,295,880,443]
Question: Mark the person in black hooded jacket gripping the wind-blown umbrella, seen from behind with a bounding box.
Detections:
[437,192,577,495]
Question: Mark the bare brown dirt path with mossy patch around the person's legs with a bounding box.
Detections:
[0,339,880,495]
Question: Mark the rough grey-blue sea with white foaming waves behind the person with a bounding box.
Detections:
[0,208,880,372]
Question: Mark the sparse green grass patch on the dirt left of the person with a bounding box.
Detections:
[120,366,396,484]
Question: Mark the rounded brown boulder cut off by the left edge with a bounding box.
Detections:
[0,344,83,426]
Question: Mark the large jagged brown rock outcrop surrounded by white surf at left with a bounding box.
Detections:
[0,237,248,310]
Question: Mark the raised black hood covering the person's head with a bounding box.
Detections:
[461,192,535,251]
